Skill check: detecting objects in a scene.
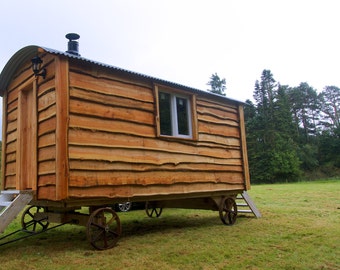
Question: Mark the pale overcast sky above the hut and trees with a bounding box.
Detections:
[0,0,340,104]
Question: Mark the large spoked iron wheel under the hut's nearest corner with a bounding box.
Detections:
[87,208,122,250]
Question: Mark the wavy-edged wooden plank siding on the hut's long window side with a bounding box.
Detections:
[68,62,244,198]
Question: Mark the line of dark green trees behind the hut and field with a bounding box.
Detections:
[208,70,340,183]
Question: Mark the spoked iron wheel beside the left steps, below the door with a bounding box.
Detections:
[21,205,50,233]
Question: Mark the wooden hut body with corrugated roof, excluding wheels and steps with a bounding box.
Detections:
[0,34,255,250]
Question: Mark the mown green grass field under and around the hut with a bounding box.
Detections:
[0,180,340,270]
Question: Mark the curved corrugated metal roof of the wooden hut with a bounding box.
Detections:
[0,45,243,103]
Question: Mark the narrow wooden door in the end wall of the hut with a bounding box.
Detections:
[16,81,37,190]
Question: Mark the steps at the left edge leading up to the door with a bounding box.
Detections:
[0,190,33,233]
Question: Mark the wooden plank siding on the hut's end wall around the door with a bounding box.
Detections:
[3,54,56,199]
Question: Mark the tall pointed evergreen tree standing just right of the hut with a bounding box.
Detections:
[245,70,300,183]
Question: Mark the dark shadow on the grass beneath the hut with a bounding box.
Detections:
[0,209,255,252]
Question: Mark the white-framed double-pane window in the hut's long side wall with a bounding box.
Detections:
[158,91,192,138]
